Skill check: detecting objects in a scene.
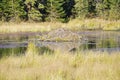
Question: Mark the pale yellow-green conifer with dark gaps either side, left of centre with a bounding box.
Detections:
[25,0,43,21]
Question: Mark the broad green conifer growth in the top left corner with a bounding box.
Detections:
[0,0,25,21]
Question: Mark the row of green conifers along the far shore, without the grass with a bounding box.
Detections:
[0,0,120,22]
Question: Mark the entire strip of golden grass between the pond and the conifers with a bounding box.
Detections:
[0,19,120,33]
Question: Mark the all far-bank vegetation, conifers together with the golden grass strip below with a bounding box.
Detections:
[0,0,120,33]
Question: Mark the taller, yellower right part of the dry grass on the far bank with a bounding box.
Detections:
[68,19,120,30]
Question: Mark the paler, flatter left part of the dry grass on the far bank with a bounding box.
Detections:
[0,22,63,33]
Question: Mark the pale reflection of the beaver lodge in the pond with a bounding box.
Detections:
[37,42,81,51]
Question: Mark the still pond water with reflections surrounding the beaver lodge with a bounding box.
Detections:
[0,31,120,56]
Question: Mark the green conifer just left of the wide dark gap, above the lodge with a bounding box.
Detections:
[47,0,65,22]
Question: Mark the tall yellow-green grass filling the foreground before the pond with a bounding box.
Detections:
[0,50,120,80]
